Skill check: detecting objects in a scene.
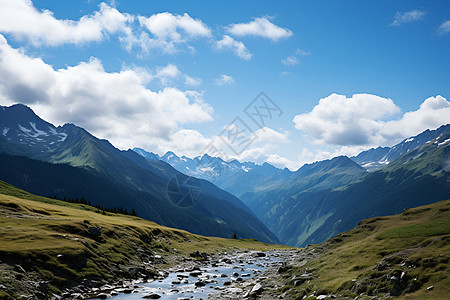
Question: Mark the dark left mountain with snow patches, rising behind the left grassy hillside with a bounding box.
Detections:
[0,104,278,243]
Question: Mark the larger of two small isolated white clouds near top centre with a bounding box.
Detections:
[227,17,292,42]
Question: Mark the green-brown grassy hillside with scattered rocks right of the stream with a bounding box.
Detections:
[281,200,450,299]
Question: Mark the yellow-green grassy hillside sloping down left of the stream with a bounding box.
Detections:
[0,181,283,299]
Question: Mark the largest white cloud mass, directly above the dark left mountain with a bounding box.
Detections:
[0,35,212,148]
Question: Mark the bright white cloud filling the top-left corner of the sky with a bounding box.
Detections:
[0,0,132,46]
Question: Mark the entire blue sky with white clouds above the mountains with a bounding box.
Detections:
[0,0,450,170]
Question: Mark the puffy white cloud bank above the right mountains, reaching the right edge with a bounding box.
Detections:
[293,94,450,147]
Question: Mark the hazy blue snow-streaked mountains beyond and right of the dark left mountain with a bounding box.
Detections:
[133,125,450,246]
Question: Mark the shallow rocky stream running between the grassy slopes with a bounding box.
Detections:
[89,251,283,300]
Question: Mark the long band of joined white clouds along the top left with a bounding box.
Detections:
[0,0,212,55]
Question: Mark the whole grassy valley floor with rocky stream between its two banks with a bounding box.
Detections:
[0,182,450,299]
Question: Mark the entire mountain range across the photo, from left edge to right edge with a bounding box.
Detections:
[0,105,450,246]
